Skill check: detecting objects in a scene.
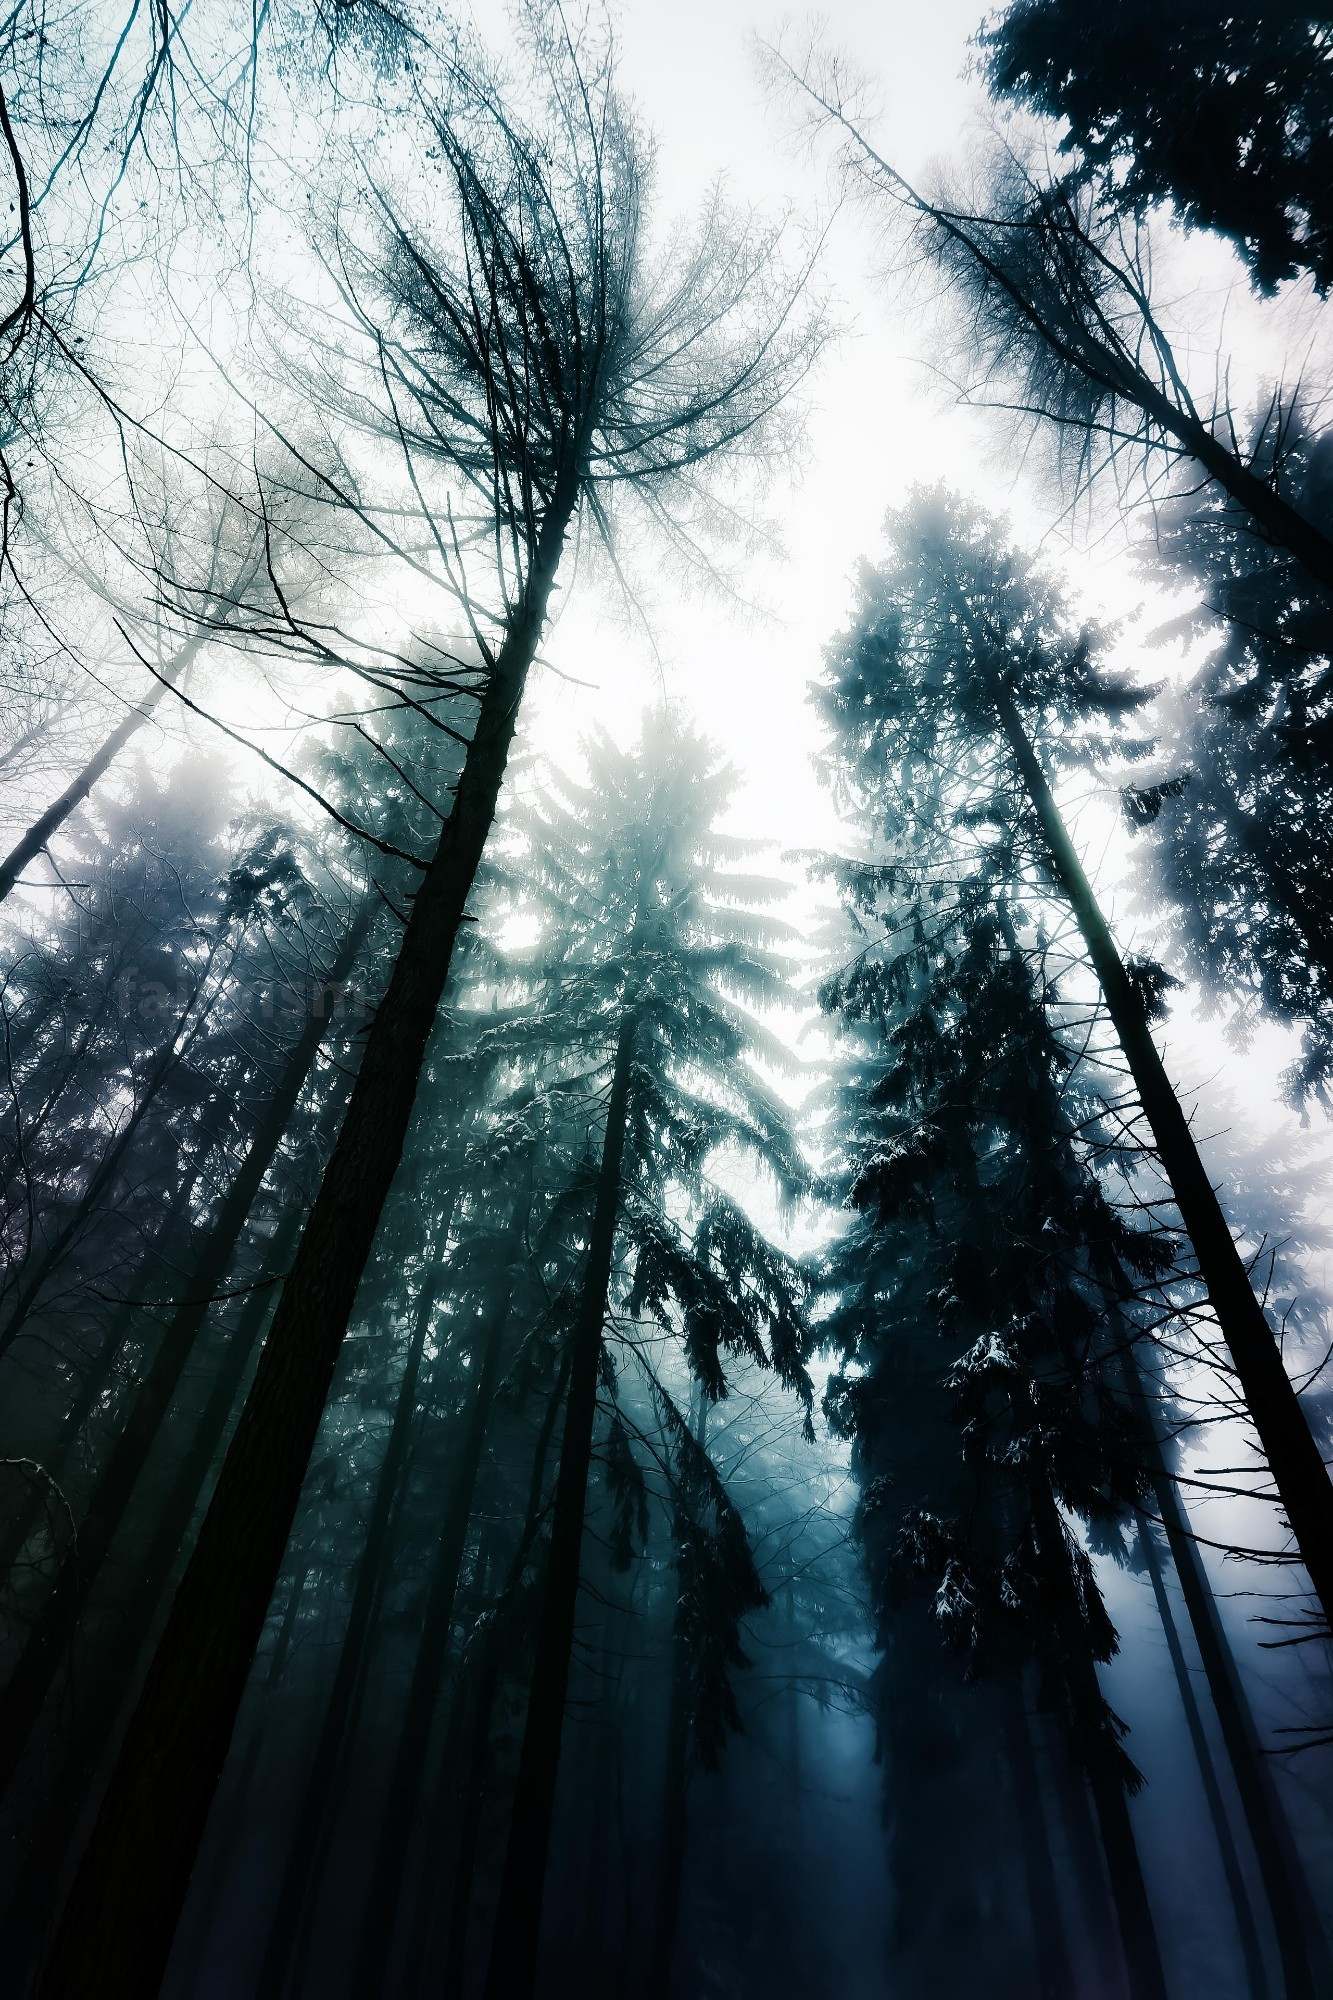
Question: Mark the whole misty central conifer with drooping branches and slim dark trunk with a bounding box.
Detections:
[486,716,809,2000]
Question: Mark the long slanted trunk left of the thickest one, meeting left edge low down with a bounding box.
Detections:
[0,898,374,1792]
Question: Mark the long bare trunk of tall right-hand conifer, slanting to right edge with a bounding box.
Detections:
[993,686,1333,1628]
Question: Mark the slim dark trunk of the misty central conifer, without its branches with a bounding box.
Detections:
[484,1012,636,2000]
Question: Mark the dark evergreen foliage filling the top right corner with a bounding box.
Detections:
[979,0,1333,292]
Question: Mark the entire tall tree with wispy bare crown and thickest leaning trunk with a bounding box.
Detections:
[33,11,813,1996]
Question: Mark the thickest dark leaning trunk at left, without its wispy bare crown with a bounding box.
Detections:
[40,494,574,2000]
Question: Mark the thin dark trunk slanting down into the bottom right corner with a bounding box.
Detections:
[1123,1348,1333,2000]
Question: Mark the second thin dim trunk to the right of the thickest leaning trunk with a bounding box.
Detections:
[350,1264,526,2000]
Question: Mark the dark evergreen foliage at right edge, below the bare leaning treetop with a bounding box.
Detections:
[1125,408,1333,1100]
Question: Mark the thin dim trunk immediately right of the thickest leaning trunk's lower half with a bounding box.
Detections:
[254,1248,448,2000]
